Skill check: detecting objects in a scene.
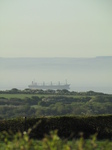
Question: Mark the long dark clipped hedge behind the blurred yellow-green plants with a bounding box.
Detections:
[0,115,112,139]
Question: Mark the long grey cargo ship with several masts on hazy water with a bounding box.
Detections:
[28,81,70,90]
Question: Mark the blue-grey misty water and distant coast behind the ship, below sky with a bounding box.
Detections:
[0,57,112,94]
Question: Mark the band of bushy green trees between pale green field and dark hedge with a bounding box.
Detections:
[0,94,112,119]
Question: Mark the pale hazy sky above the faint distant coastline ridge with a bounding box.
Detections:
[0,0,112,57]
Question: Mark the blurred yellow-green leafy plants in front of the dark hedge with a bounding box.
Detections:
[0,130,112,150]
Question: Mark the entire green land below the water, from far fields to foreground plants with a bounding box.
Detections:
[0,89,112,150]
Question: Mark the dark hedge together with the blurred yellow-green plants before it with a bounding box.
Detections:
[0,115,112,150]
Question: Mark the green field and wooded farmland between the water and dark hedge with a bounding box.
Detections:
[0,89,112,119]
